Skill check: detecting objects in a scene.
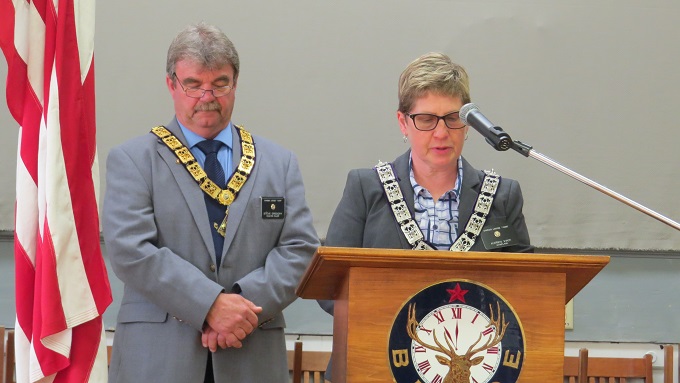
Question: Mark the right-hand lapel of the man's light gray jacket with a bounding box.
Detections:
[222,124,258,259]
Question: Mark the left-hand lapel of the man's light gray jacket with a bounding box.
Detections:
[157,119,215,261]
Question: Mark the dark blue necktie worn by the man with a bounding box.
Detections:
[196,140,227,269]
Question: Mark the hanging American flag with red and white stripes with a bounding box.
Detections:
[0,0,112,383]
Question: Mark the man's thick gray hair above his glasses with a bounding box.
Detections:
[165,22,240,81]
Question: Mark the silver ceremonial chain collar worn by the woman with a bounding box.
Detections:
[374,162,500,251]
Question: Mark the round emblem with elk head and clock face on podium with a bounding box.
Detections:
[388,280,524,383]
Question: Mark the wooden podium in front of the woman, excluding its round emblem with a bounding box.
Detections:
[297,246,609,383]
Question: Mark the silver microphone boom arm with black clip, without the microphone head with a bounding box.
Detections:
[504,140,680,230]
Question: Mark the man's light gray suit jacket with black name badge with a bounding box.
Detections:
[103,119,319,383]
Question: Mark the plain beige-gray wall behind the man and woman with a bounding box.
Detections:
[0,0,680,250]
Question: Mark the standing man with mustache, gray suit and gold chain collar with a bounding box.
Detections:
[103,23,319,383]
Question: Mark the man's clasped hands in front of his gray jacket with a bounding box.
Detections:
[201,293,262,352]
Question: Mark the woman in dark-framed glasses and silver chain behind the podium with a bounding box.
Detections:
[325,53,533,252]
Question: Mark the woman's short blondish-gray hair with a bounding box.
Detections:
[399,52,470,113]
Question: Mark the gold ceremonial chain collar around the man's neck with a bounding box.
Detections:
[151,125,255,236]
